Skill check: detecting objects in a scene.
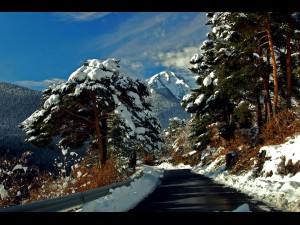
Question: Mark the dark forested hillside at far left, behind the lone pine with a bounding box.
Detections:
[0,82,61,168]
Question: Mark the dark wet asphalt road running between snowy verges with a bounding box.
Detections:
[129,169,279,212]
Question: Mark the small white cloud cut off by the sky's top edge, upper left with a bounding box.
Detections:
[54,12,110,22]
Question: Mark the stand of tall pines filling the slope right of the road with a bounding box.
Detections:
[181,12,300,147]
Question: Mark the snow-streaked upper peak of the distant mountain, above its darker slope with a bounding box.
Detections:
[146,71,196,100]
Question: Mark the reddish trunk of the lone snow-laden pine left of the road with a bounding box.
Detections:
[91,93,105,167]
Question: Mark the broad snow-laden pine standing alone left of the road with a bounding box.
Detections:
[20,58,162,165]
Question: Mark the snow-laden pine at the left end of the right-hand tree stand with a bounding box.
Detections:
[181,13,237,149]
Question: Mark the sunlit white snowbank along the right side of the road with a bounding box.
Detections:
[193,135,300,212]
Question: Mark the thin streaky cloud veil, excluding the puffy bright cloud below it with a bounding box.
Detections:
[89,12,208,58]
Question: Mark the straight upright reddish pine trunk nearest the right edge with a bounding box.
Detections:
[286,14,292,109]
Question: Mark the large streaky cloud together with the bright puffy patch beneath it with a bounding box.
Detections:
[86,12,209,75]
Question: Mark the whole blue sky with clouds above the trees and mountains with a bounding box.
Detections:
[0,12,208,90]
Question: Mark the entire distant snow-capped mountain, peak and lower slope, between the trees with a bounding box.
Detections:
[146,71,196,129]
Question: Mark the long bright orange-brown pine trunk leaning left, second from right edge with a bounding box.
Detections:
[266,12,278,114]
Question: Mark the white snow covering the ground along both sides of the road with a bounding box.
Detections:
[82,135,300,212]
